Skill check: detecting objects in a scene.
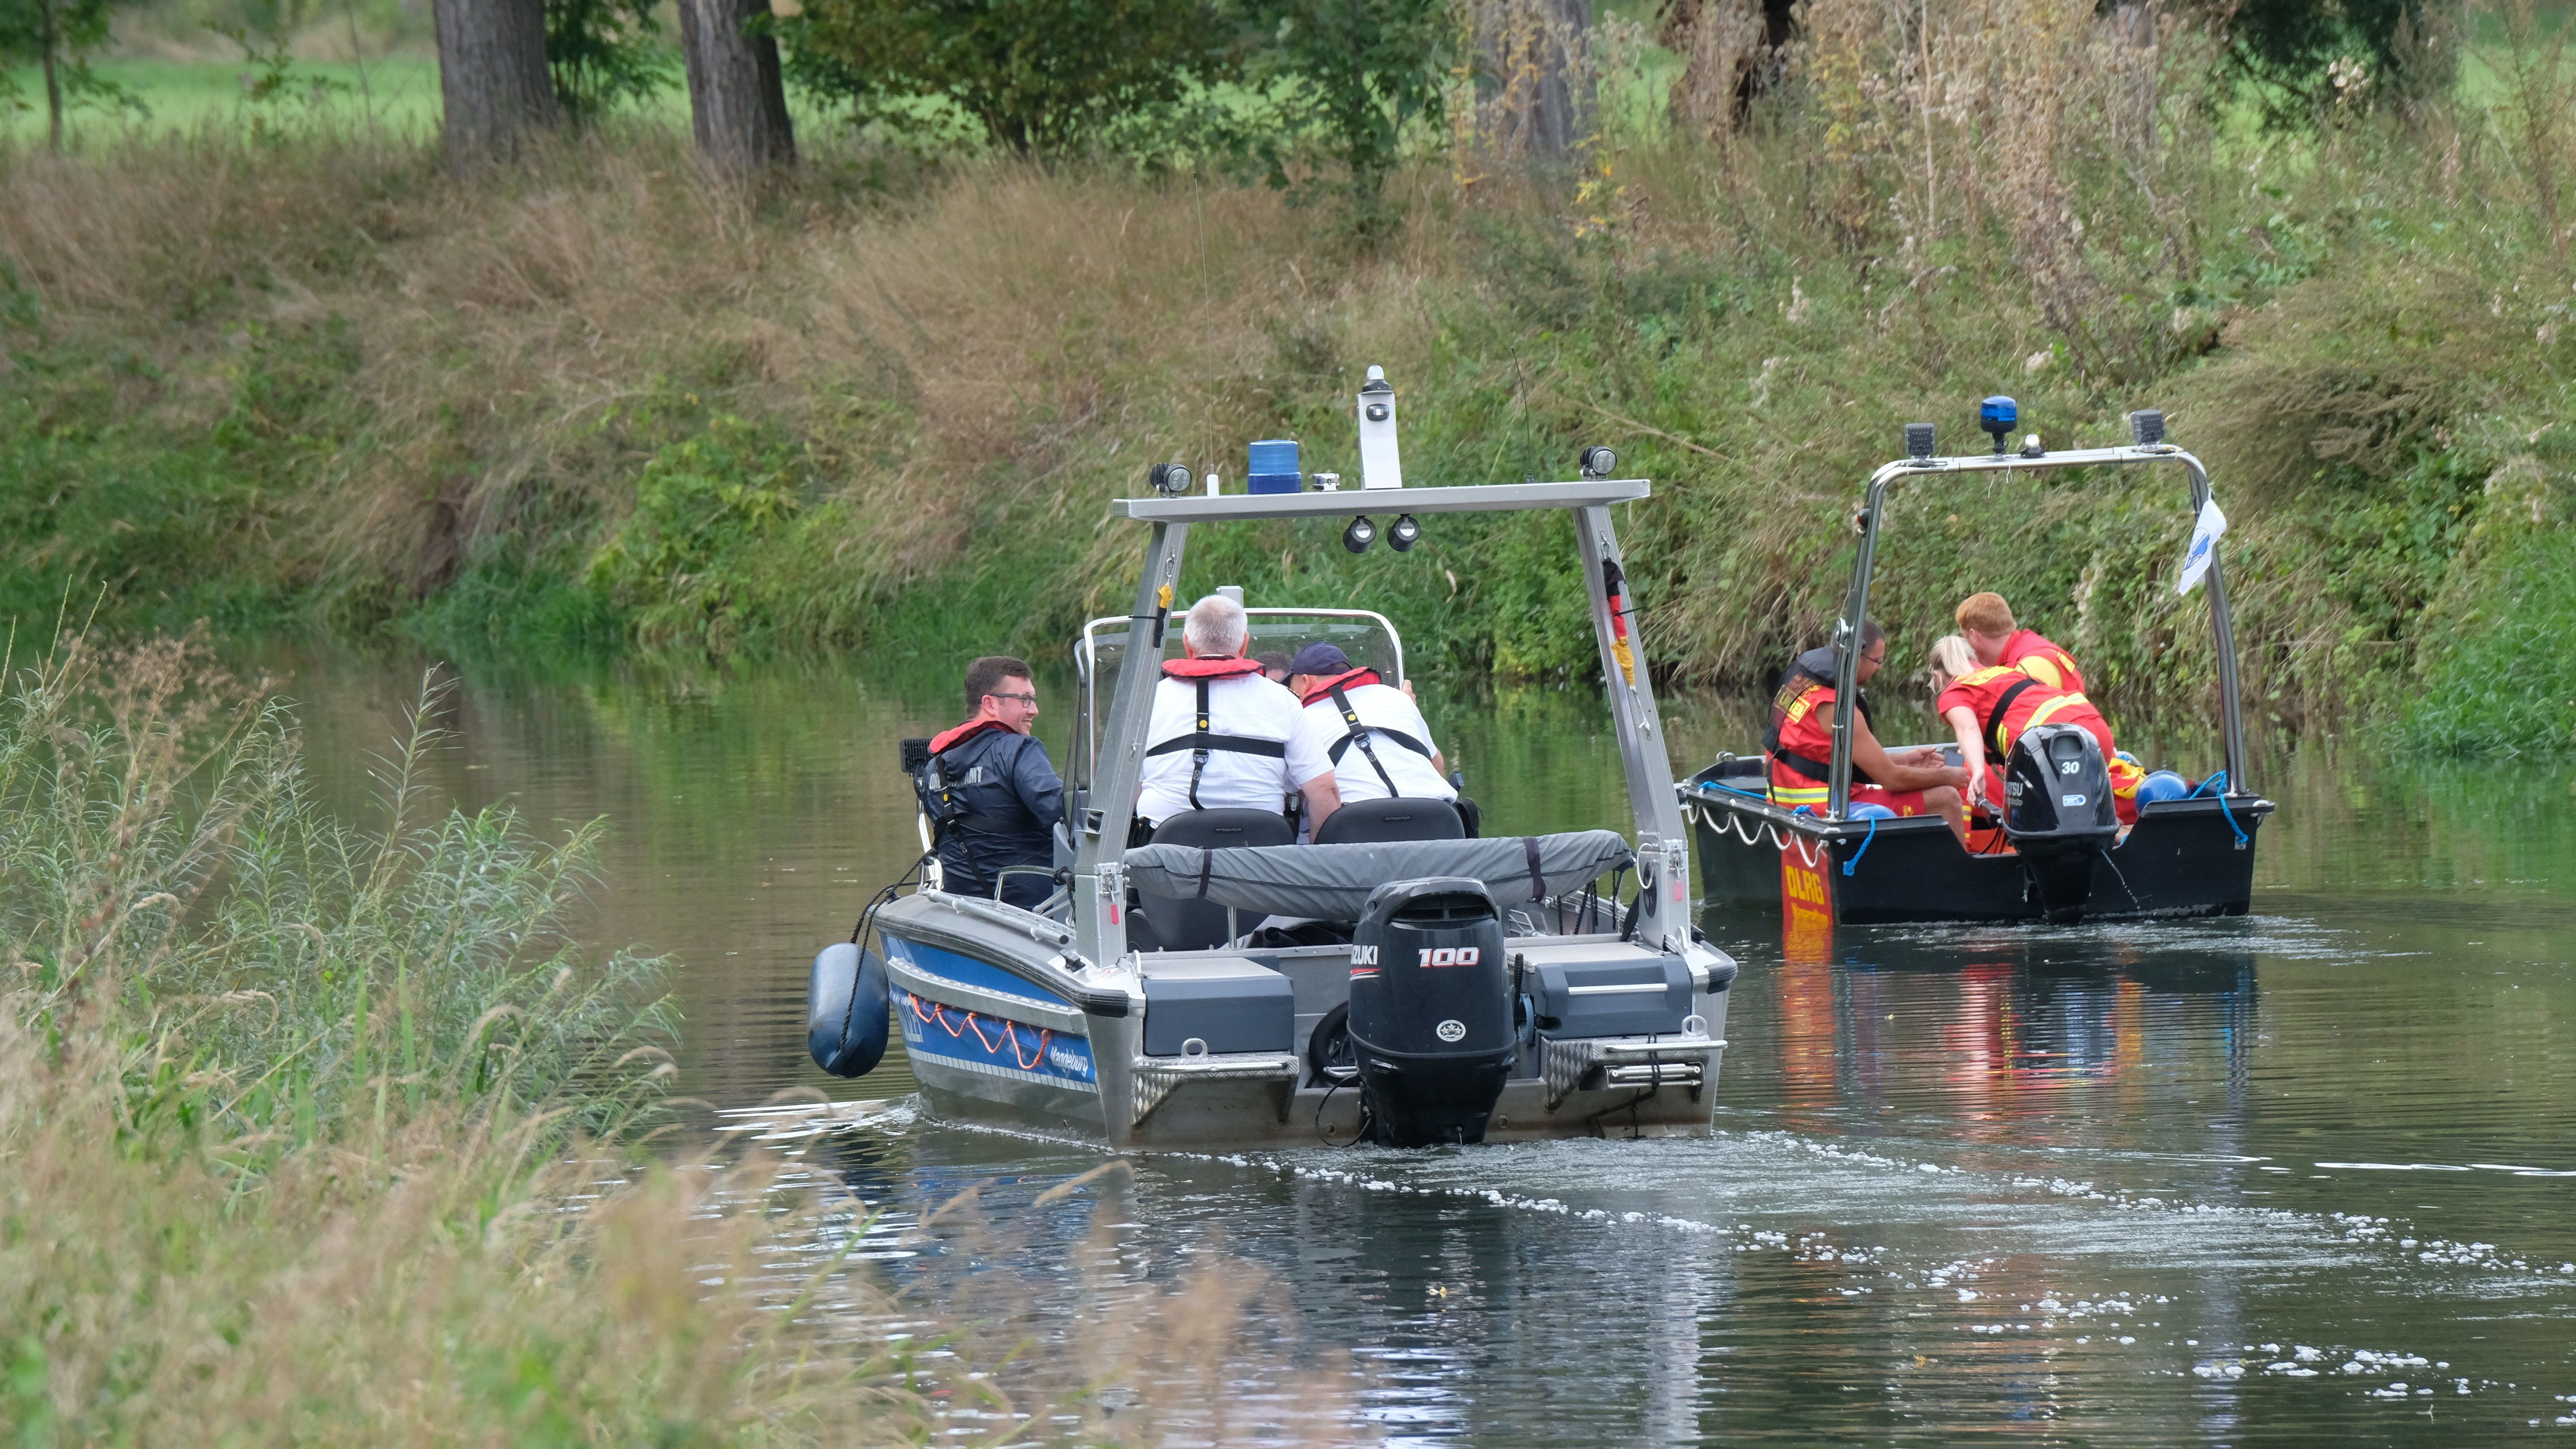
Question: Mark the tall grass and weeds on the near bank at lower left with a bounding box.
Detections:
[0,639,1342,1446]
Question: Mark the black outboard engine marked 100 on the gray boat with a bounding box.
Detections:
[1350,877,1520,1147]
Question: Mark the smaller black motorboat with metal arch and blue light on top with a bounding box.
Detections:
[1680,397,2272,923]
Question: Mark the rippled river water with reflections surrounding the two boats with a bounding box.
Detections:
[282,655,2576,1444]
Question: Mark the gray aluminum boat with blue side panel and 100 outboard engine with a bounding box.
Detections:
[811,461,1736,1147]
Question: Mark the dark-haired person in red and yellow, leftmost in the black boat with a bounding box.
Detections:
[1762,619,1968,841]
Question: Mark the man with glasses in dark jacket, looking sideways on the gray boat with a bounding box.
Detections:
[925,655,1064,908]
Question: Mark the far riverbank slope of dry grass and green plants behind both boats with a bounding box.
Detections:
[0,14,2576,748]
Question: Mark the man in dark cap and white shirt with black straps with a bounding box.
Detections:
[1288,642,1458,830]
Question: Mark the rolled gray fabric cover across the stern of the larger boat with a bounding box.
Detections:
[1121,830,1636,920]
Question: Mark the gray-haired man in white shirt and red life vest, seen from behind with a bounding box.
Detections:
[1136,593,1298,823]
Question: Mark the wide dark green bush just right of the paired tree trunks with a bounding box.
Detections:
[783,0,1244,155]
